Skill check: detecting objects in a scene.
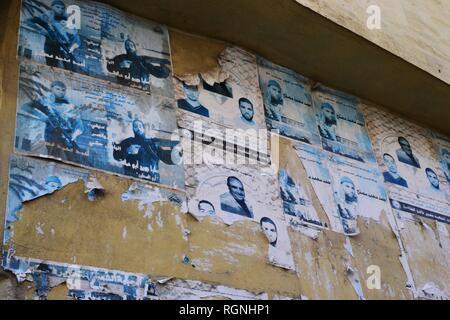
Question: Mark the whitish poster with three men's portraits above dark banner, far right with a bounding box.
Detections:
[365,106,450,223]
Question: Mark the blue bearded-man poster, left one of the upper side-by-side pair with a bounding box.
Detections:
[258,57,320,145]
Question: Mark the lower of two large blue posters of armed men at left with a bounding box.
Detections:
[16,63,184,189]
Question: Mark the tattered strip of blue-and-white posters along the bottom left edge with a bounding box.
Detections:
[2,253,151,300]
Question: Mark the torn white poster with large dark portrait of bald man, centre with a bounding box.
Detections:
[183,142,282,224]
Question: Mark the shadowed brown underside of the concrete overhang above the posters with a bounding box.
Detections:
[102,0,450,134]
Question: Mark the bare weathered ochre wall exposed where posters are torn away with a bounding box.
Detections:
[0,1,450,299]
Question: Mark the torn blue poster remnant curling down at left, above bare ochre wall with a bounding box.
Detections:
[3,155,89,244]
